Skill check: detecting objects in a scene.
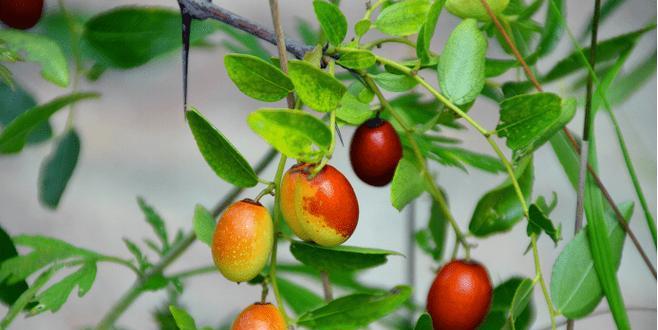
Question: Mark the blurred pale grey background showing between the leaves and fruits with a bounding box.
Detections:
[0,0,656,329]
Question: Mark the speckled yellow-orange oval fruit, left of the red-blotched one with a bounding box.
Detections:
[211,199,274,282]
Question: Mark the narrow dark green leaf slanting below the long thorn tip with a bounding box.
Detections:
[185,109,258,187]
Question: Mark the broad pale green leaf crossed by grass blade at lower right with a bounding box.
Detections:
[551,202,633,319]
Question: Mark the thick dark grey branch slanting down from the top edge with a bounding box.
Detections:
[178,0,314,59]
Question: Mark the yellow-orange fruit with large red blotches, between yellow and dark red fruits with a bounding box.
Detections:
[281,164,359,246]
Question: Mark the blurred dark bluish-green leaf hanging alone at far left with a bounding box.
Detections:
[39,129,80,209]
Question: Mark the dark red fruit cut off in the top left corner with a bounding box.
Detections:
[0,0,43,30]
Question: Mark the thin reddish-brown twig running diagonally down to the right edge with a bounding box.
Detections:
[481,0,656,278]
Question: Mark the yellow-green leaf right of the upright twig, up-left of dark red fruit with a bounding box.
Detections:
[288,61,347,112]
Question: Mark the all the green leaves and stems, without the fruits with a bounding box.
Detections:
[0,0,656,329]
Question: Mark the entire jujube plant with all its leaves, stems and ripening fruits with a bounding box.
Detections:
[0,0,656,329]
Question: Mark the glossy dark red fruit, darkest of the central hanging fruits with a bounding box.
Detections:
[350,118,402,187]
